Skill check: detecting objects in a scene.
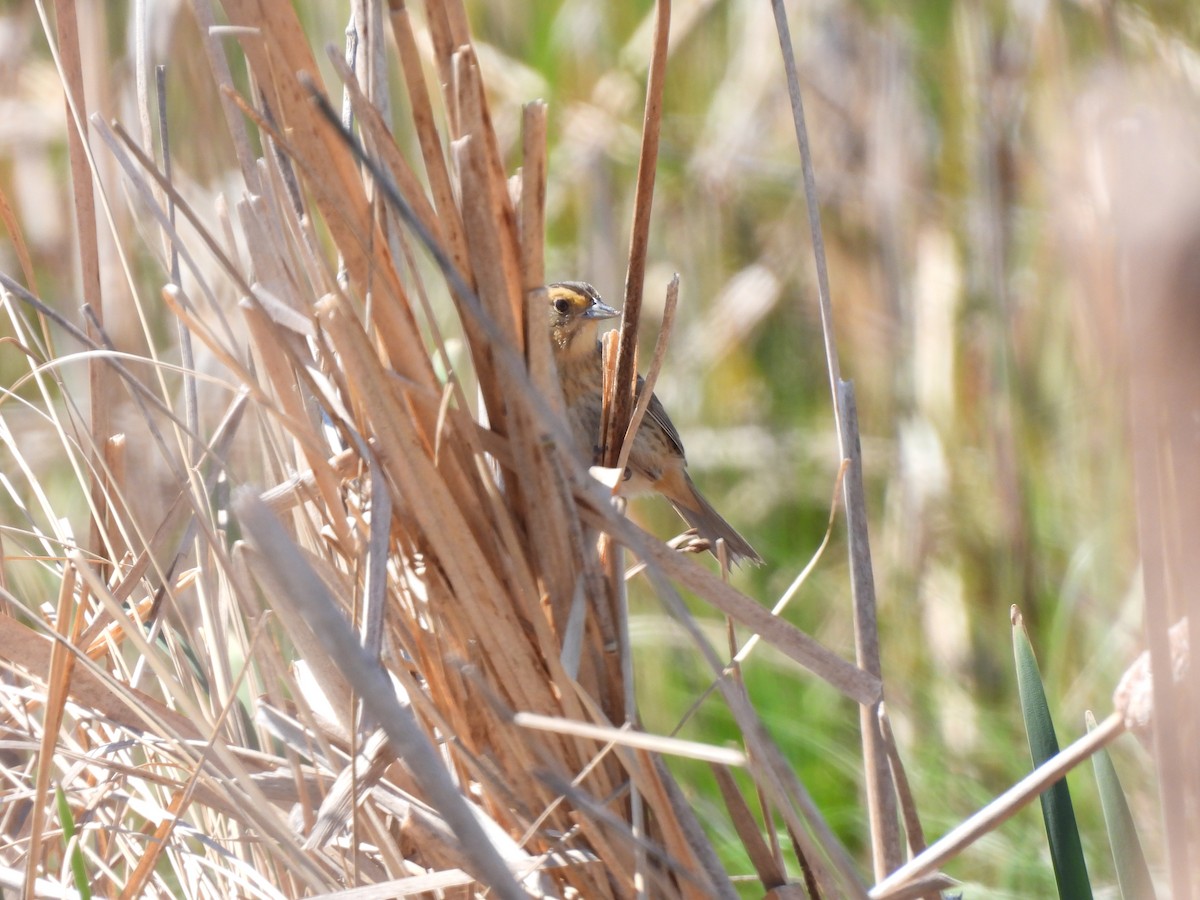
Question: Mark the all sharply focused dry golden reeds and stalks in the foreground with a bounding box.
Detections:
[0,0,1195,898]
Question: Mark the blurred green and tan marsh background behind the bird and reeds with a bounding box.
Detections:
[0,0,1200,898]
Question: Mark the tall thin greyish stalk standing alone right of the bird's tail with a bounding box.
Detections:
[772,0,901,878]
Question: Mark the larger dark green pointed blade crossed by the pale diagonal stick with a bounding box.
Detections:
[1013,606,1092,900]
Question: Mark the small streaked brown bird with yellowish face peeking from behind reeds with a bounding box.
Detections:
[546,281,762,565]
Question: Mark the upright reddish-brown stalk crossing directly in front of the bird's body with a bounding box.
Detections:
[601,0,671,468]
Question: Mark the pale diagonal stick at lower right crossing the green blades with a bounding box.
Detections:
[870,713,1124,900]
